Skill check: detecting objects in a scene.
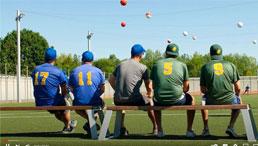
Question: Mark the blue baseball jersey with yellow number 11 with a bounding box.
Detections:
[69,64,105,106]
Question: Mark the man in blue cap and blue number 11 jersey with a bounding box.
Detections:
[69,51,105,134]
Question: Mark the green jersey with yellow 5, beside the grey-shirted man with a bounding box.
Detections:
[151,58,189,104]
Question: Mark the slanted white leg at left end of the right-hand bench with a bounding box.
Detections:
[99,110,112,140]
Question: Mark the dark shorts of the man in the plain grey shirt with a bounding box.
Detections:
[114,97,149,106]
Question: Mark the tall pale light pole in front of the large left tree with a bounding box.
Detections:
[15,10,24,102]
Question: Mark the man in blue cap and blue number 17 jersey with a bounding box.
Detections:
[31,48,77,133]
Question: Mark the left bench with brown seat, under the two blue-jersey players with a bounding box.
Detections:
[0,106,104,139]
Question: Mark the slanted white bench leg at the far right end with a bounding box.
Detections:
[241,107,258,141]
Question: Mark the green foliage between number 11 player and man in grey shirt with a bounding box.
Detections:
[93,54,120,78]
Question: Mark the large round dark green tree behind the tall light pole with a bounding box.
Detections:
[0,29,48,74]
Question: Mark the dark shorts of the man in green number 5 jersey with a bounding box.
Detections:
[154,93,193,106]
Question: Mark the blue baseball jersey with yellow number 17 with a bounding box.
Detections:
[31,63,67,106]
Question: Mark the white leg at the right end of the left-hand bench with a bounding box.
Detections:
[87,110,98,139]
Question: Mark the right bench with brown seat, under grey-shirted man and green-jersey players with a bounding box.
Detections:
[99,104,258,141]
